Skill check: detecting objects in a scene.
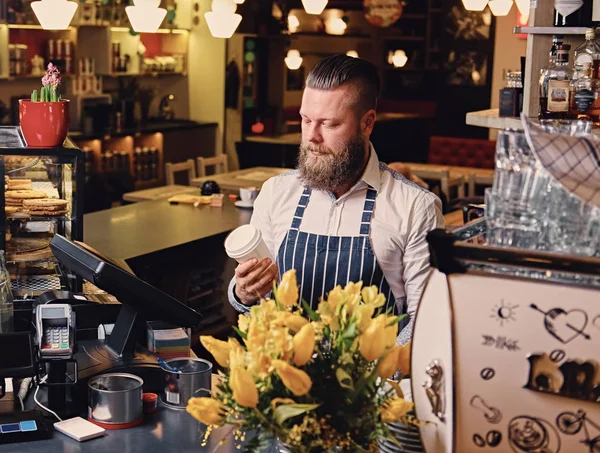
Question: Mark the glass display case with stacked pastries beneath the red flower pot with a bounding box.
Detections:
[0,126,84,301]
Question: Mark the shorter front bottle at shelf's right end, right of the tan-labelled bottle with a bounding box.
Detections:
[569,64,600,126]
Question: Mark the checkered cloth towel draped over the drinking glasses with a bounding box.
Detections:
[522,116,600,208]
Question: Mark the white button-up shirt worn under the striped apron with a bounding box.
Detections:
[229,145,444,340]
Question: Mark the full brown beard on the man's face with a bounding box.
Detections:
[298,134,365,192]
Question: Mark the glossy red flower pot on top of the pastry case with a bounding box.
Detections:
[19,99,69,148]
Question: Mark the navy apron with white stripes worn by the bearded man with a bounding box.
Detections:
[277,188,399,315]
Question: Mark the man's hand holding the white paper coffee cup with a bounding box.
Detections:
[235,258,278,305]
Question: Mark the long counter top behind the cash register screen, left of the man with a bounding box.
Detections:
[83,198,252,264]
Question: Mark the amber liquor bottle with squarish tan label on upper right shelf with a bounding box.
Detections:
[540,44,573,119]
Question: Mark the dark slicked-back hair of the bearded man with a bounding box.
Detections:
[306,54,381,116]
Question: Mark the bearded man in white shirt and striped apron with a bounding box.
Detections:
[229,55,443,344]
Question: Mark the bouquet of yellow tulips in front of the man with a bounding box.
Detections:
[187,270,416,453]
